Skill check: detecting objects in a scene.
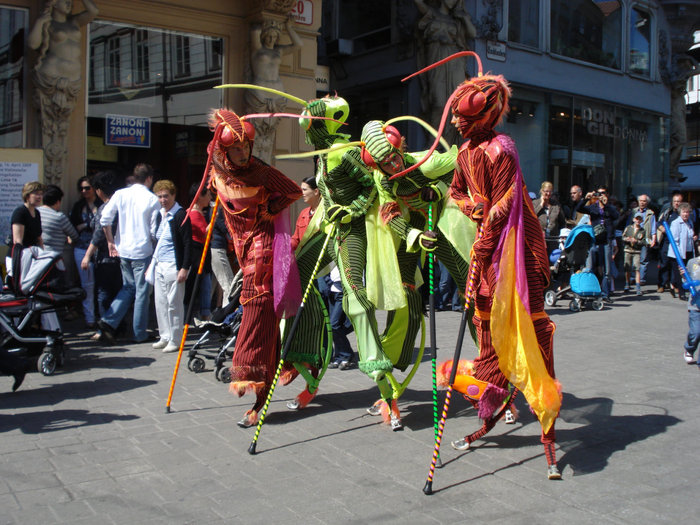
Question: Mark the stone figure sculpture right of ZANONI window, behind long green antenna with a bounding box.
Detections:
[245,18,302,164]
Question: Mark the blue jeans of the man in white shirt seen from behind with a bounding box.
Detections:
[102,257,151,343]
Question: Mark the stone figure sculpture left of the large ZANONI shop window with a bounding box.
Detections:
[27,0,98,184]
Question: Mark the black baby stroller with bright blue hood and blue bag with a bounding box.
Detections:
[544,224,603,312]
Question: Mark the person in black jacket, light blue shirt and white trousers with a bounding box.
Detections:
[151,180,192,353]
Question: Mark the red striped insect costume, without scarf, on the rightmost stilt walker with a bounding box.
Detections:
[451,70,560,478]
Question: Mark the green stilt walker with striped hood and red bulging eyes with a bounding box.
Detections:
[362,117,475,422]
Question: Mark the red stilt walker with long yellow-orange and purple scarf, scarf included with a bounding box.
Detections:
[402,52,561,479]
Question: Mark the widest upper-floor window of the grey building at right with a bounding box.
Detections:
[550,0,623,69]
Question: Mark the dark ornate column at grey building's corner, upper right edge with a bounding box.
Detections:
[659,0,700,185]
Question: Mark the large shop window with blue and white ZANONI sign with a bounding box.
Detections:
[86,21,224,192]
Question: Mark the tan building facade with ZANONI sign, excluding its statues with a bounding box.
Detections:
[0,0,321,227]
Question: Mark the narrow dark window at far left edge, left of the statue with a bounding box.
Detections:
[0,7,28,148]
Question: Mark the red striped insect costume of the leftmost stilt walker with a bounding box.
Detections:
[202,109,301,427]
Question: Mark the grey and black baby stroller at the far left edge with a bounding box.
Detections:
[0,245,85,391]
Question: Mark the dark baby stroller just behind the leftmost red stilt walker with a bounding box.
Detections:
[187,270,243,383]
